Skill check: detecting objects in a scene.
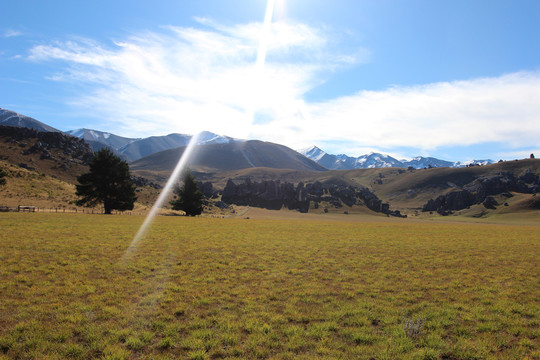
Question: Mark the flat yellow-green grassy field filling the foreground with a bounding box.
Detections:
[0,213,540,360]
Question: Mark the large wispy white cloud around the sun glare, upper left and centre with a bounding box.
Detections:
[29,19,362,137]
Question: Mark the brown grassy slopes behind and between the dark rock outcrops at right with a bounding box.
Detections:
[192,159,540,215]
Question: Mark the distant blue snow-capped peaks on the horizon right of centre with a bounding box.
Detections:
[298,146,493,170]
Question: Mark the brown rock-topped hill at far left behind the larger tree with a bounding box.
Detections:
[0,126,159,211]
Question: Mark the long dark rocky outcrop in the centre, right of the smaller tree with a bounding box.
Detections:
[222,179,406,217]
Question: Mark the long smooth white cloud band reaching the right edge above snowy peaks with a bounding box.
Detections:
[294,72,540,150]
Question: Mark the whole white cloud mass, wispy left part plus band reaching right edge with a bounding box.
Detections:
[29,18,540,158]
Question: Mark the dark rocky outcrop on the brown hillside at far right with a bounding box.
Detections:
[422,169,540,215]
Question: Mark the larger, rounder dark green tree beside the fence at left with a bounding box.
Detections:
[76,148,137,214]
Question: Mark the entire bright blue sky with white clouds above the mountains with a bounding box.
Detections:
[0,0,540,161]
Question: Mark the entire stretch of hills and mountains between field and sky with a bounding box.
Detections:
[0,106,540,217]
